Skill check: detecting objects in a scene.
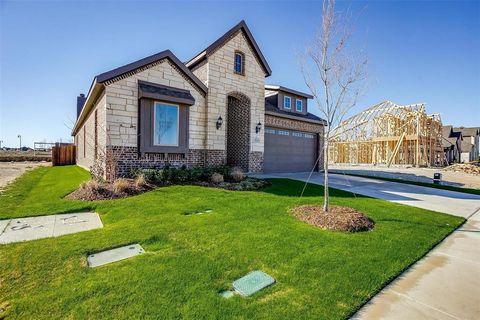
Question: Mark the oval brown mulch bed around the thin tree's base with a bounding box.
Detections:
[292,205,375,232]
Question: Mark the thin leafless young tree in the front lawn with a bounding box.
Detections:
[300,0,367,212]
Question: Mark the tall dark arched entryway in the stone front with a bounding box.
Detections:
[226,92,250,172]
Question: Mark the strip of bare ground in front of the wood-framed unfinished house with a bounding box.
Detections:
[330,165,480,189]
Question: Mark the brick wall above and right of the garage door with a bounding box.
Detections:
[265,114,325,171]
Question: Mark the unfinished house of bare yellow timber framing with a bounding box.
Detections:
[329,101,444,167]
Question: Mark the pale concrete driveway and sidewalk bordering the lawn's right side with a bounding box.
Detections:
[255,173,480,319]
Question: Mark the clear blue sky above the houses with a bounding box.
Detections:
[0,0,480,147]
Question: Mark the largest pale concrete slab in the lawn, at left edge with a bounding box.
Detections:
[0,212,103,244]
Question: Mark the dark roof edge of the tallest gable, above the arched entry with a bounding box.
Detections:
[185,20,272,77]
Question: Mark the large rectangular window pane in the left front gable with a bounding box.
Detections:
[153,102,179,146]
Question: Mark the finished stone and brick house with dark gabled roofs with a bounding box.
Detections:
[72,21,325,177]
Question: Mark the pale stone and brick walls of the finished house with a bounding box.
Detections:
[75,22,323,176]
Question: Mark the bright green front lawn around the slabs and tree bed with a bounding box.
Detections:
[0,166,463,319]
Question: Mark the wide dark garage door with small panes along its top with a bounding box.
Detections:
[263,127,318,172]
